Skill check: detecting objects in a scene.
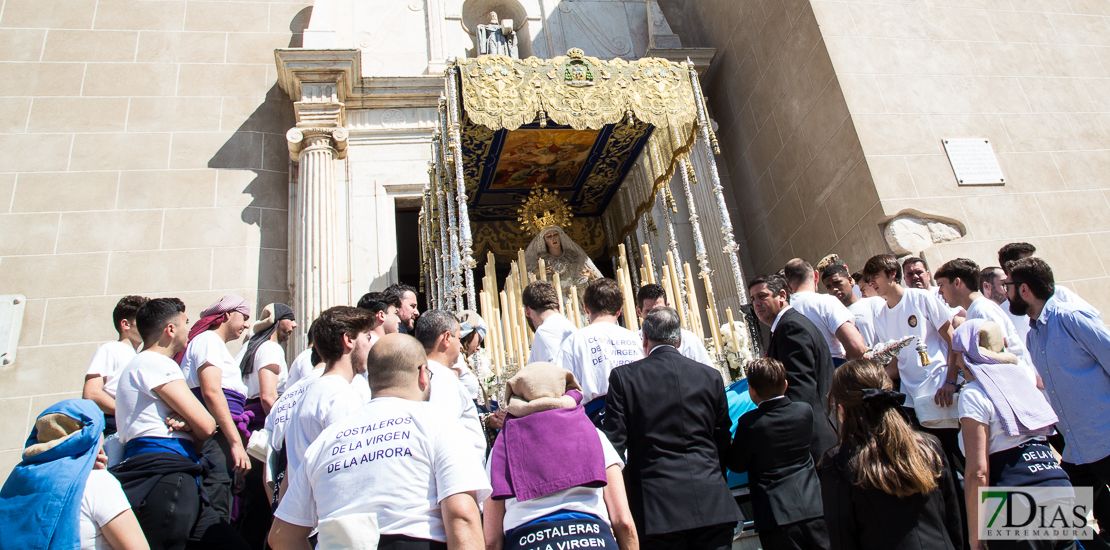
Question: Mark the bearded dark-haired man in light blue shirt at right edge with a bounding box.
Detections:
[1005,258,1110,542]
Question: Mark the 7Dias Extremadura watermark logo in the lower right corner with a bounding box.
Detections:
[979,487,1094,540]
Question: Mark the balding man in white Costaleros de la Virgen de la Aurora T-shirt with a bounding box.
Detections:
[270,333,492,550]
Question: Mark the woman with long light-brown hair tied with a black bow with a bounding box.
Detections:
[818,359,963,550]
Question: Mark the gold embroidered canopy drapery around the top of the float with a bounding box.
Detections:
[456,48,698,254]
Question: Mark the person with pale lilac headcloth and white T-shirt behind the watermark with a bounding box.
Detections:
[952,319,1074,550]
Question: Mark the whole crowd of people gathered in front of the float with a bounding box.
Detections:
[0,243,1110,550]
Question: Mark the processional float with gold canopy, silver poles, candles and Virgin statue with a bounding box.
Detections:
[420,49,760,402]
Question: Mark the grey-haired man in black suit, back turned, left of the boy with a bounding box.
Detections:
[602,307,740,550]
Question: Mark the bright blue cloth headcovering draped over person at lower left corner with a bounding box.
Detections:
[0,399,104,550]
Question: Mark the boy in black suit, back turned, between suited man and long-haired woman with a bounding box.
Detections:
[728,358,829,550]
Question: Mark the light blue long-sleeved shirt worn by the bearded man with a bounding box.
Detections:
[1026,296,1110,464]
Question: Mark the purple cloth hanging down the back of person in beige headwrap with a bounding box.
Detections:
[490,404,606,500]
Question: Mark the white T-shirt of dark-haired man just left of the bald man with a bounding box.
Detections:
[285,374,370,473]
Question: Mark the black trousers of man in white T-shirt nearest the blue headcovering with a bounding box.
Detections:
[134,473,249,550]
